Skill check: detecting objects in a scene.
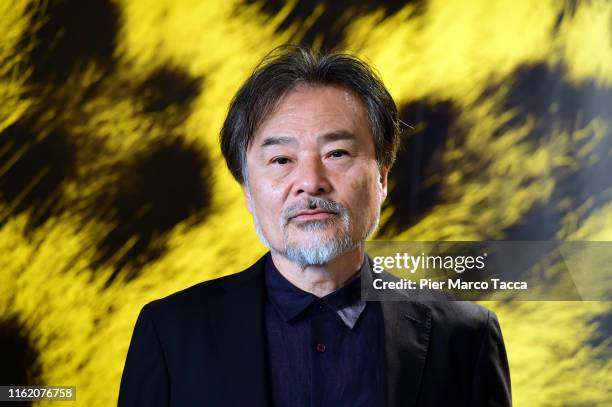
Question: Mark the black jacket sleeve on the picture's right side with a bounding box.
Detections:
[472,311,512,407]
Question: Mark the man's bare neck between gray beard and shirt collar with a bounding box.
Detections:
[272,245,364,298]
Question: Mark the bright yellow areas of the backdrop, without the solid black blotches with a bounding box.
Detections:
[0,0,612,406]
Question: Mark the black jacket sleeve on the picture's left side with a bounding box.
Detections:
[118,304,169,407]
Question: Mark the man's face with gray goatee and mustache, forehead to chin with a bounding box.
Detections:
[244,86,387,266]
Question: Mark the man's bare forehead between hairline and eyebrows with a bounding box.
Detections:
[252,85,372,145]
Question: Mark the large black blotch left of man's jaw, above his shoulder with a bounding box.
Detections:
[94,138,212,281]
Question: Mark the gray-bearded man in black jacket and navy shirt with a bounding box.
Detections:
[119,46,511,407]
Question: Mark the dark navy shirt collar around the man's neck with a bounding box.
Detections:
[265,253,369,329]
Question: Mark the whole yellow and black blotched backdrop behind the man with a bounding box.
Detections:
[0,0,612,406]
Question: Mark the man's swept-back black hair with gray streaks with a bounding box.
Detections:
[220,45,400,184]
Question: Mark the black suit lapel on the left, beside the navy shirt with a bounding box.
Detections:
[209,258,269,407]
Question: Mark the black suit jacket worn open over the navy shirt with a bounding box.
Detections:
[119,253,511,407]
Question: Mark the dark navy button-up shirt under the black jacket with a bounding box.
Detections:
[265,254,384,407]
